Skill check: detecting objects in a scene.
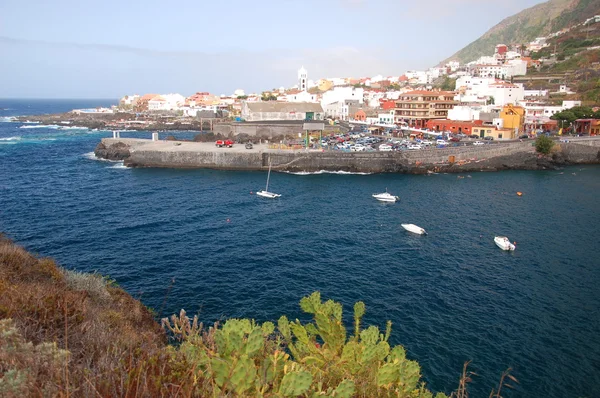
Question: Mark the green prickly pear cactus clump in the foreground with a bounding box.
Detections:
[163,292,446,398]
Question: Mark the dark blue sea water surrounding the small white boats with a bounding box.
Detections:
[0,100,600,397]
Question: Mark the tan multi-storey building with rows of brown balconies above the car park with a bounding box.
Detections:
[394,91,458,128]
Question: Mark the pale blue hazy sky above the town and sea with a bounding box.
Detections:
[0,0,542,98]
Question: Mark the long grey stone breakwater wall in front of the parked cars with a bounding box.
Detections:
[95,138,600,174]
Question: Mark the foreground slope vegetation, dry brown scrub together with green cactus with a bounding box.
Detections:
[0,235,516,398]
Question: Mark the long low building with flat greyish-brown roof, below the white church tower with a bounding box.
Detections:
[241,101,324,122]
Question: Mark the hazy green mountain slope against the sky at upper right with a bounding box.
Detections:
[440,0,600,65]
